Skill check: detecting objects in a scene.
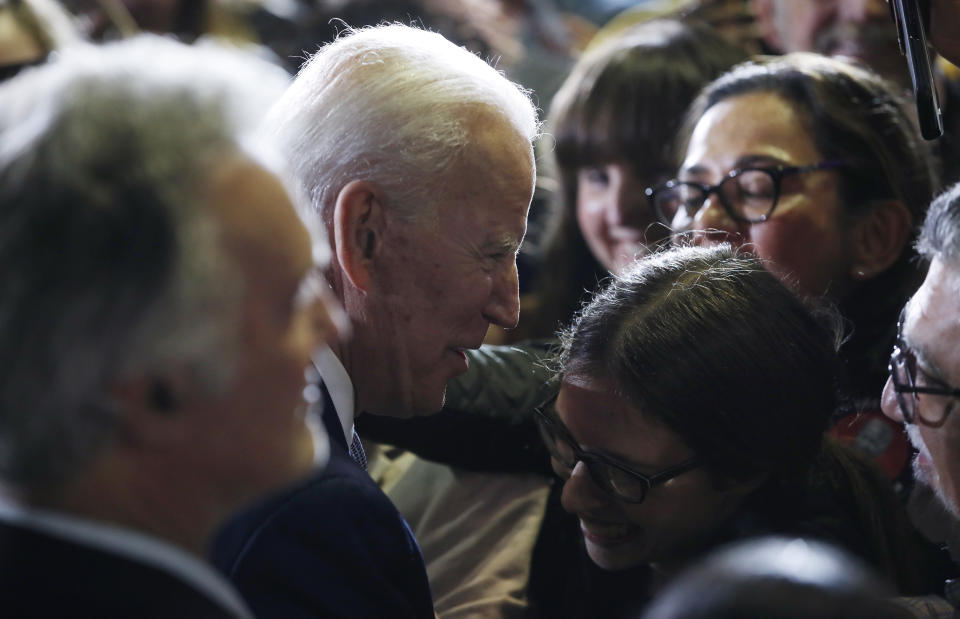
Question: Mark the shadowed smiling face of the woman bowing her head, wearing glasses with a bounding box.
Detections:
[553,377,740,571]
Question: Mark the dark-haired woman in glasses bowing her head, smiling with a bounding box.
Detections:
[531,246,932,618]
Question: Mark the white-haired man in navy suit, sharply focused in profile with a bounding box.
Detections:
[214,25,538,618]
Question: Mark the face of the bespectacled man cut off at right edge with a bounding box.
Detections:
[881,259,960,517]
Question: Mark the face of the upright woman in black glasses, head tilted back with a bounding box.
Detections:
[679,92,853,298]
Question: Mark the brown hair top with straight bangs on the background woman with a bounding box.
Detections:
[550,20,747,168]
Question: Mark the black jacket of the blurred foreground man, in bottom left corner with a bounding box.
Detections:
[0,523,240,619]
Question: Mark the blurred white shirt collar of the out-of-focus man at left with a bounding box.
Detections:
[0,496,253,619]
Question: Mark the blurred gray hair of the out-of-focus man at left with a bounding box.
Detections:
[0,37,287,490]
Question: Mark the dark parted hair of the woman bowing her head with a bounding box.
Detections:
[560,245,928,590]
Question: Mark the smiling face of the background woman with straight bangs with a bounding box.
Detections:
[577,160,671,273]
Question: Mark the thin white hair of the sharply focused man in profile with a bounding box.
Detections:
[267,24,539,225]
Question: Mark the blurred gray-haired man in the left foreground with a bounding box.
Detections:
[0,38,336,619]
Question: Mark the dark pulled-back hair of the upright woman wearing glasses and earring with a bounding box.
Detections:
[679,53,939,399]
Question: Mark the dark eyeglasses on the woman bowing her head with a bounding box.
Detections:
[534,400,703,504]
